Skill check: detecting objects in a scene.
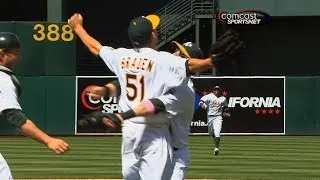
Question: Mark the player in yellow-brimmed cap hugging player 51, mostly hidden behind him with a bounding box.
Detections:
[85,41,203,180]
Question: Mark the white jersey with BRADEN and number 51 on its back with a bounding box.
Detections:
[99,46,187,123]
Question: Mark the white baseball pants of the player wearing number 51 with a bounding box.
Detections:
[122,121,173,180]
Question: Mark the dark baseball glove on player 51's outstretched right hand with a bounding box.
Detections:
[211,29,246,63]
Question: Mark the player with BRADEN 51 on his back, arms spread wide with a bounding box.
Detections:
[68,14,213,179]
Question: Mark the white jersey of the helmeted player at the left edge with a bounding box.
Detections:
[0,66,21,114]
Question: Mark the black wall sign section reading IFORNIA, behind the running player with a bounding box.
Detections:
[191,77,285,134]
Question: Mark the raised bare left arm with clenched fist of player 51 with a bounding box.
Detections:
[68,13,102,56]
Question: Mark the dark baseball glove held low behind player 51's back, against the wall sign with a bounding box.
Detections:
[78,110,121,131]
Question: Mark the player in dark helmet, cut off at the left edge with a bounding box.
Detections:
[0,32,69,180]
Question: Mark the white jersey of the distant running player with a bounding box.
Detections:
[200,93,228,116]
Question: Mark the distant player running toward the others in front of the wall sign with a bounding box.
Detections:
[199,86,231,155]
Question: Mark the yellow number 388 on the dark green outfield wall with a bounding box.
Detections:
[33,24,74,41]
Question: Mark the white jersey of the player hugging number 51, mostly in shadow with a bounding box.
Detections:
[158,80,195,148]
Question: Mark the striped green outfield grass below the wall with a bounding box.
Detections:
[0,136,320,180]
